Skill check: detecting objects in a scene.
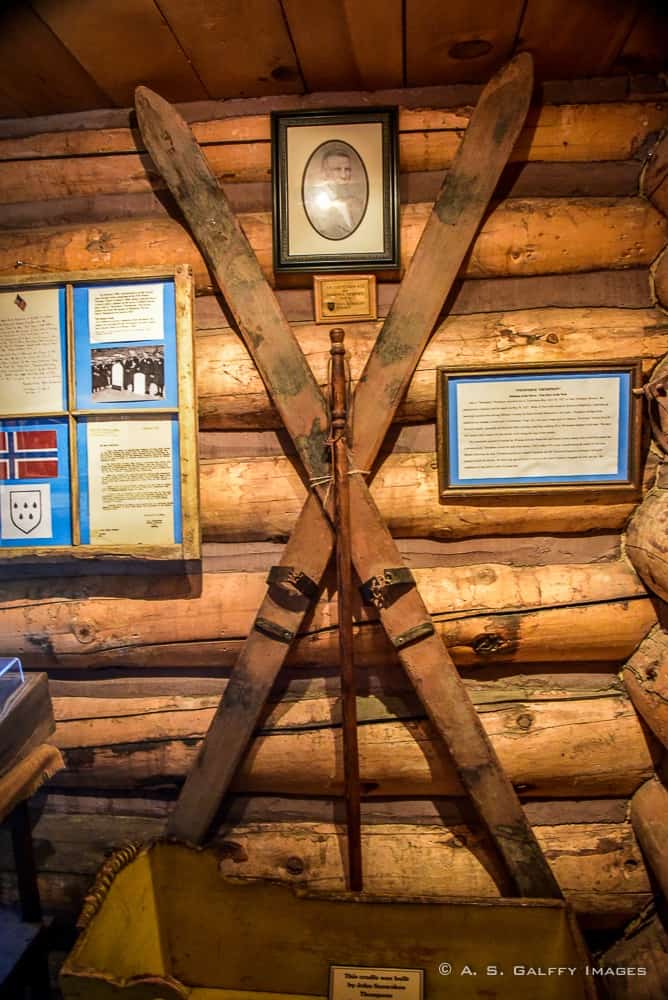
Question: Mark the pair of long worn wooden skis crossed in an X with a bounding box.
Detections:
[137,56,559,896]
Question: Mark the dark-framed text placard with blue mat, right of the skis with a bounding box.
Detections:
[437,360,642,499]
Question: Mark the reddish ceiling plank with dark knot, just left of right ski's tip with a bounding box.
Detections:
[406,0,522,87]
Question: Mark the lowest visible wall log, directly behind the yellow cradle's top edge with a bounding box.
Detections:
[0,812,651,927]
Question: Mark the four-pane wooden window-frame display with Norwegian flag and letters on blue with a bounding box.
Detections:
[0,266,200,560]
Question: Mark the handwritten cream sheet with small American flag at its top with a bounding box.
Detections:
[0,288,64,414]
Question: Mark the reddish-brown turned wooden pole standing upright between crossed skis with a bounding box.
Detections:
[329,327,362,892]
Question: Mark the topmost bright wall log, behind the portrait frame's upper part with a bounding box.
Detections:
[0,103,668,215]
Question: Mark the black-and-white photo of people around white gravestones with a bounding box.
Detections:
[91,345,165,403]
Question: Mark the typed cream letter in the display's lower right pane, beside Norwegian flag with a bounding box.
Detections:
[88,420,174,545]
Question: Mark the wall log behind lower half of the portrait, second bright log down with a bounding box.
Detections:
[0,198,668,293]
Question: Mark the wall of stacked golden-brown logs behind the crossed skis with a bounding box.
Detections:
[0,80,668,928]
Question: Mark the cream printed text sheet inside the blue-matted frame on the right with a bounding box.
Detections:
[456,375,620,480]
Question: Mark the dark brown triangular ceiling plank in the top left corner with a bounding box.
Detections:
[0,4,109,115]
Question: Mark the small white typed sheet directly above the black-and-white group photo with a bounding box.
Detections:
[88,283,165,344]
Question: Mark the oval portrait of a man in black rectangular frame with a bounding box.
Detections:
[271,108,399,271]
